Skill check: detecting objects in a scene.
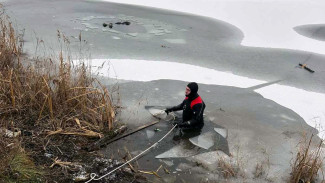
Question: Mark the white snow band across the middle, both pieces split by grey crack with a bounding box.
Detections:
[91,59,325,139]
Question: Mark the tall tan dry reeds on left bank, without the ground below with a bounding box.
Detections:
[0,10,115,135]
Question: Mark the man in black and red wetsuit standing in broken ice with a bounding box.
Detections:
[165,82,205,138]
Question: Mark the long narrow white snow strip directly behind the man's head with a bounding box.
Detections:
[88,59,265,87]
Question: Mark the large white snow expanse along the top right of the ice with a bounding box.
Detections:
[105,0,325,54]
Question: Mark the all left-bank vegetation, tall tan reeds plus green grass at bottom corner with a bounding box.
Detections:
[0,7,116,182]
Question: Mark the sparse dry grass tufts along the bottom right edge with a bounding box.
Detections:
[217,133,325,183]
